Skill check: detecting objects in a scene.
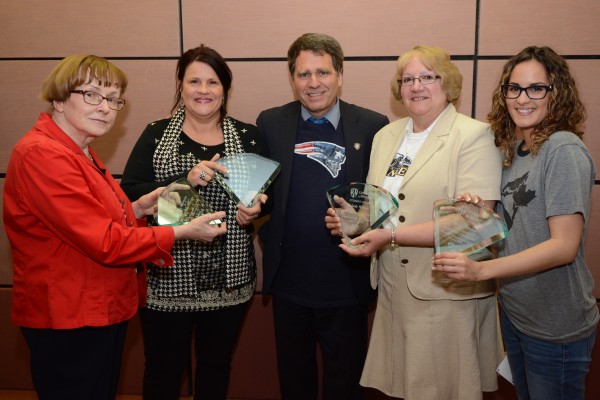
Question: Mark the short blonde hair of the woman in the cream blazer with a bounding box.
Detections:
[392,45,463,105]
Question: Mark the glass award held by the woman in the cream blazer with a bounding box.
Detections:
[326,182,398,248]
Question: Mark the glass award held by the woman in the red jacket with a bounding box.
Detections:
[155,178,221,226]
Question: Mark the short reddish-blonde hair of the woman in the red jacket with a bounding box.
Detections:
[40,55,127,103]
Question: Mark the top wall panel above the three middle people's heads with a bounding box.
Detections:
[182,0,475,58]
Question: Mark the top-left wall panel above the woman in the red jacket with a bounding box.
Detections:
[0,0,179,57]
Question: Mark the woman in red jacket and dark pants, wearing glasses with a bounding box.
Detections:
[3,55,226,400]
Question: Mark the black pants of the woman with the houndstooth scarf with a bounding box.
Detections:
[140,302,249,400]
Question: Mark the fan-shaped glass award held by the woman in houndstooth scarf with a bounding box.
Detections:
[215,153,281,207]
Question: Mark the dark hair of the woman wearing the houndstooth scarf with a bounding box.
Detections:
[171,44,233,123]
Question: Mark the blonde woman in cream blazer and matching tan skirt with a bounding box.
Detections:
[326,46,501,400]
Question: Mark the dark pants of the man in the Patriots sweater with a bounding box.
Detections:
[273,296,368,400]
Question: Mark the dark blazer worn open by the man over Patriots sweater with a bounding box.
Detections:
[256,99,389,303]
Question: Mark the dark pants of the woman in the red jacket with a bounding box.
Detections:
[21,321,127,400]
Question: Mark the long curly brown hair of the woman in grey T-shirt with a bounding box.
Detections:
[487,46,587,168]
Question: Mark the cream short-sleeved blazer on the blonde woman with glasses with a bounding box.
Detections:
[367,104,502,300]
